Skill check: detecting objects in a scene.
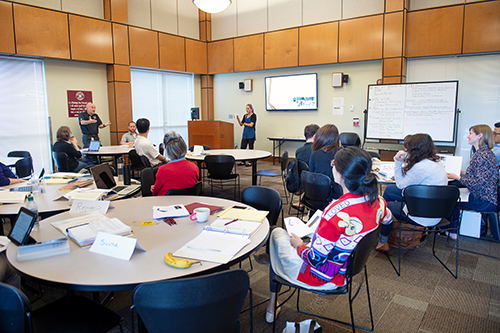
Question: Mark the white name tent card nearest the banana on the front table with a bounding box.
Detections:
[89,232,146,260]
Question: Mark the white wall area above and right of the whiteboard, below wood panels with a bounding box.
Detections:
[407,54,500,170]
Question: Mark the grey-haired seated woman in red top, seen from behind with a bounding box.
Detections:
[153,131,200,195]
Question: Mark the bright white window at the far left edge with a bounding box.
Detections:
[0,57,52,173]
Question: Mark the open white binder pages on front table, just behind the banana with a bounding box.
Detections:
[174,230,251,264]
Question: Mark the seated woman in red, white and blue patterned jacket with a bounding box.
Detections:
[266,147,392,323]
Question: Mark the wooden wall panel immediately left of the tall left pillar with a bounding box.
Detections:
[69,14,113,64]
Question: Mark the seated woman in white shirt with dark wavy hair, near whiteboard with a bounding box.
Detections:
[376,134,448,251]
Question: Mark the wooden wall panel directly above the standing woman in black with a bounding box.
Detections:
[234,34,264,72]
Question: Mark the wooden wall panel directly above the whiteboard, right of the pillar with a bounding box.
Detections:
[406,6,464,57]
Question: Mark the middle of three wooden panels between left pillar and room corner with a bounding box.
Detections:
[160,33,186,71]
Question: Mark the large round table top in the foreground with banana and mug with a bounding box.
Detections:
[6,196,269,291]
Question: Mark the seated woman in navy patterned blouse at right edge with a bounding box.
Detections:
[448,125,499,239]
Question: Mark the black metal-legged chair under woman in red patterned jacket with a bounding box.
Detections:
[273,228,379,332]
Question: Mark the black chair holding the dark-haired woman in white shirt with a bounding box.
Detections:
[386,185,462,279]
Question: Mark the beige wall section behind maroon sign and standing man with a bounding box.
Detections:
[45,59,111,146]
